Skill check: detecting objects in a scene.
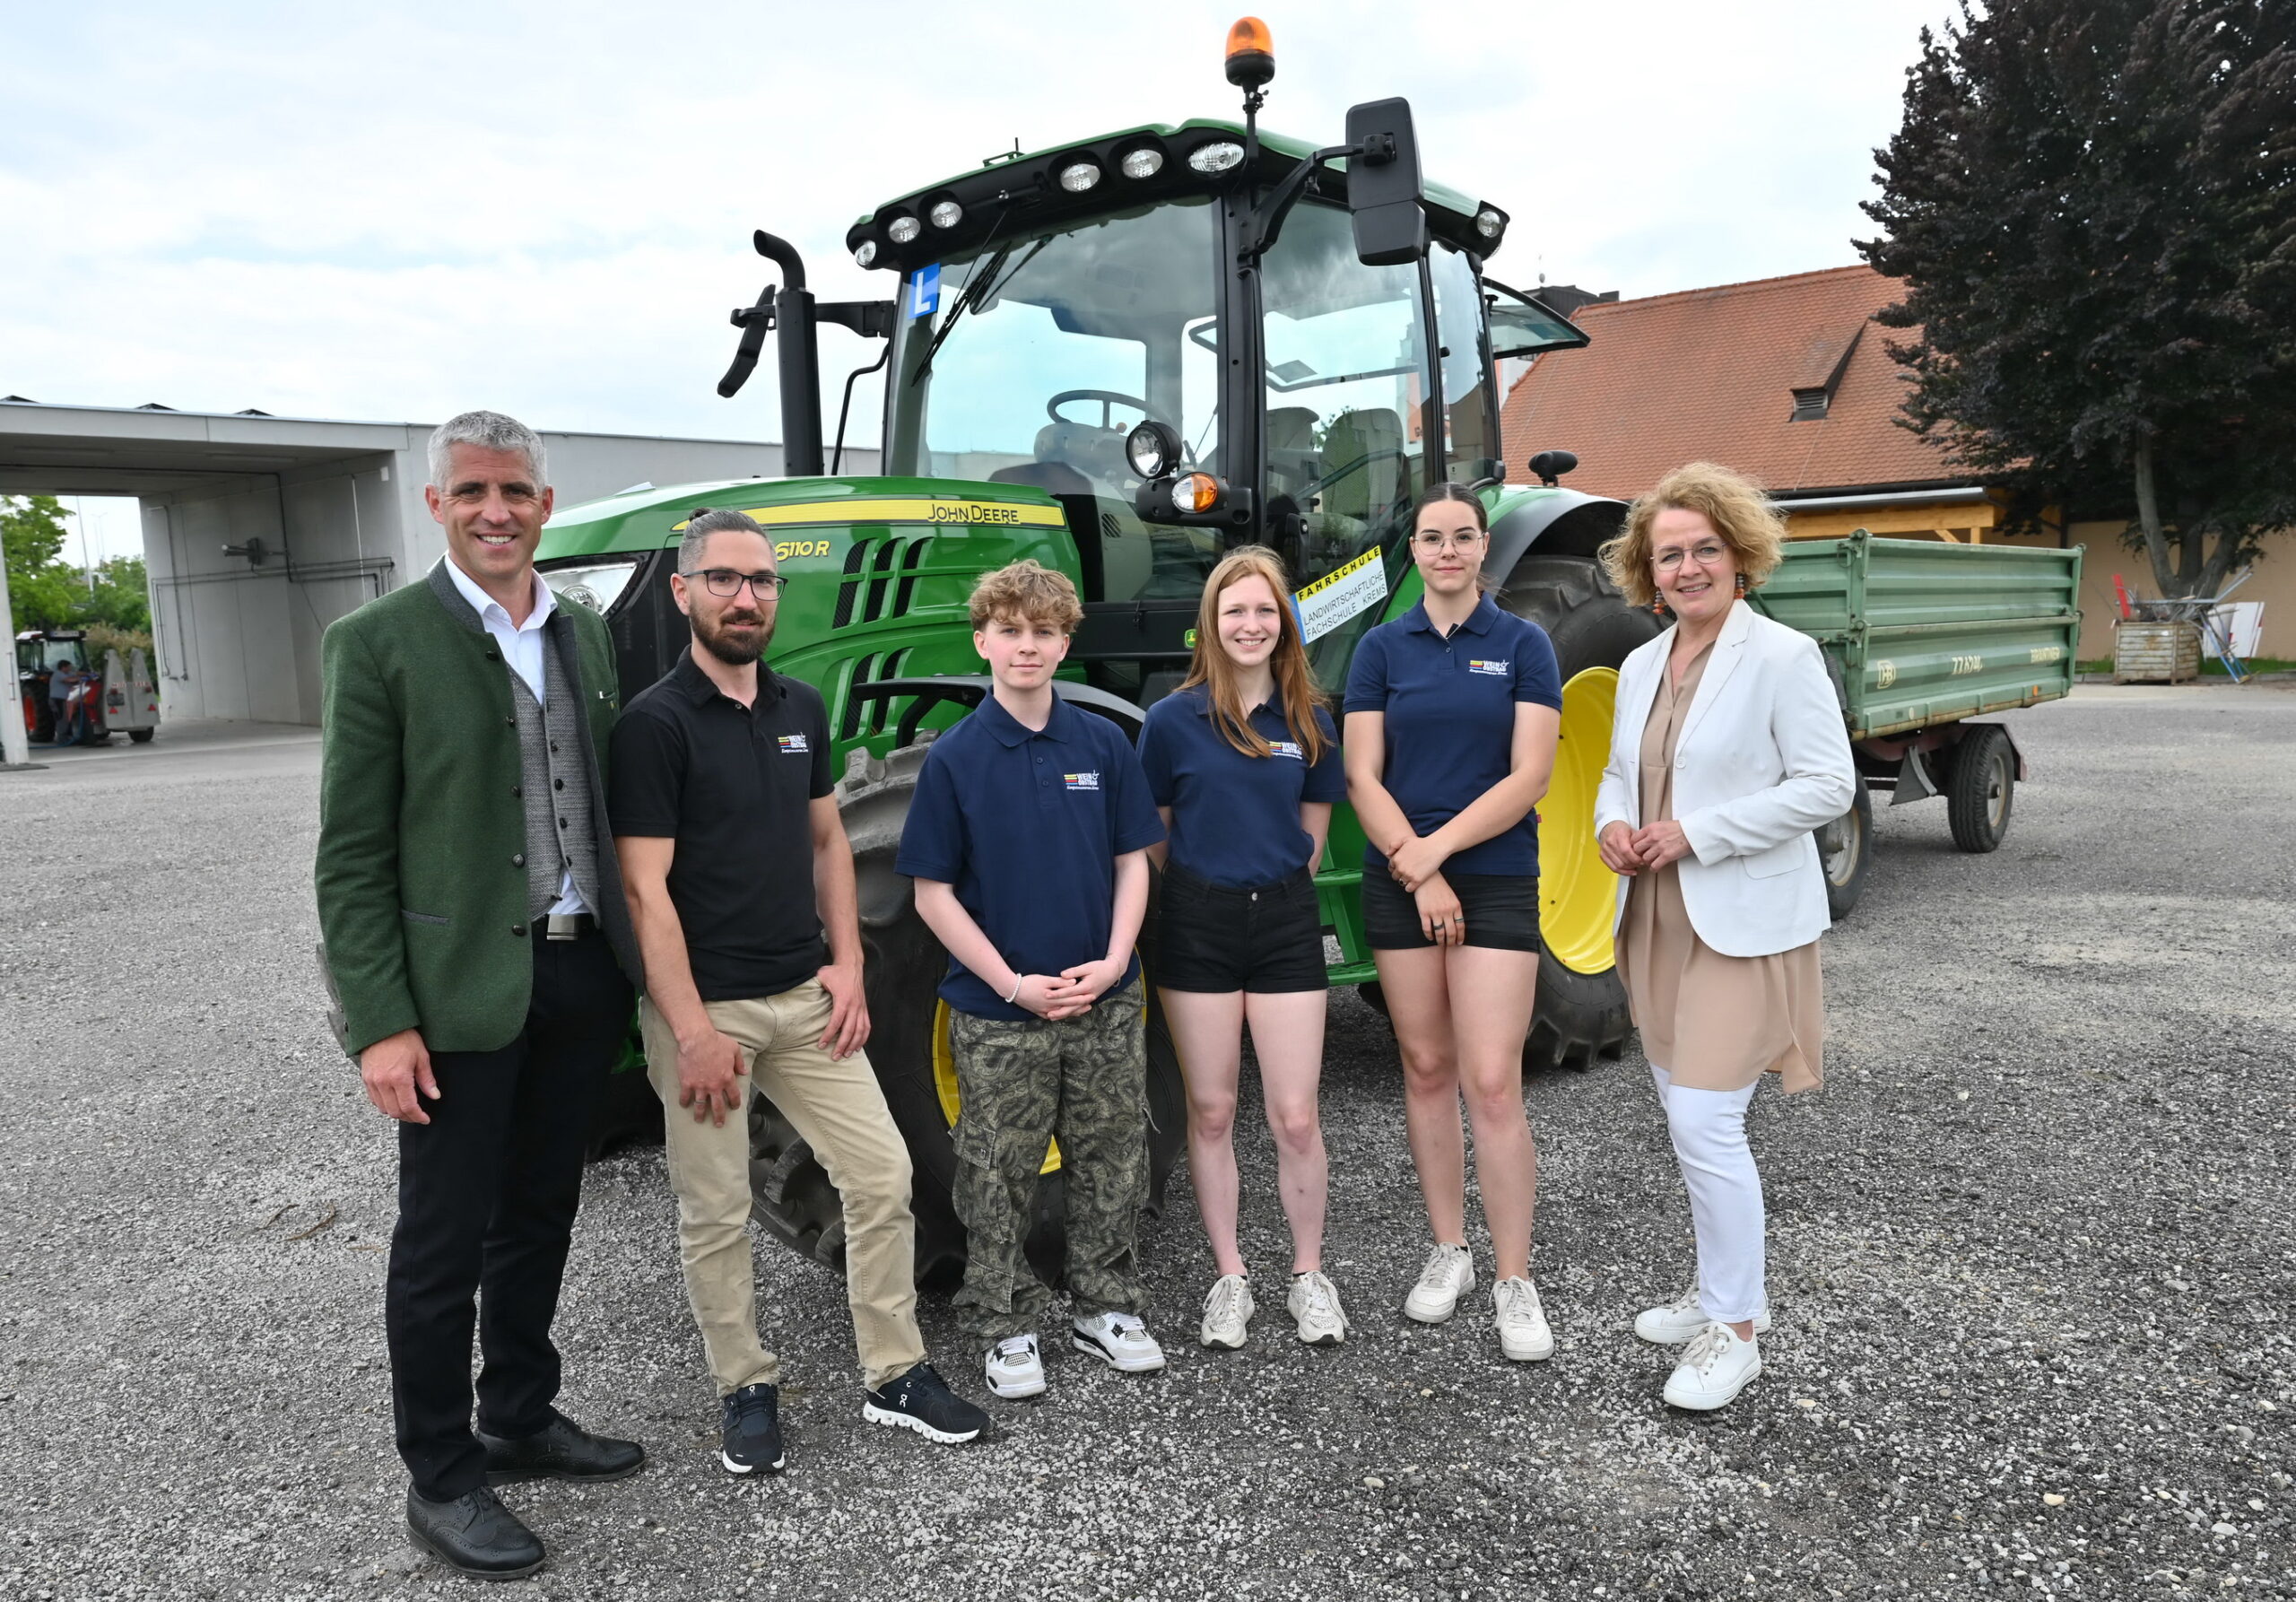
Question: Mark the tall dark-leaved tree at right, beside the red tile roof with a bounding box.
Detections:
[1857,0,2296,596]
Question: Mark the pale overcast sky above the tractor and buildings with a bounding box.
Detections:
[0,0,1947,558]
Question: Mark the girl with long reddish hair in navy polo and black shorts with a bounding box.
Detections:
[1139,546,1348,1350]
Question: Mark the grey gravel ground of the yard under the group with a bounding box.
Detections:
[0,686,2296,1599]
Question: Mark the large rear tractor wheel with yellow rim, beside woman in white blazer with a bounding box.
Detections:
[1495,553,1662,1072]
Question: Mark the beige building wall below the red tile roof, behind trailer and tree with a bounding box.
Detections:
[1787,501,2296,661]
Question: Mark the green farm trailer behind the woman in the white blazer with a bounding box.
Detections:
[1754,528,2080,918]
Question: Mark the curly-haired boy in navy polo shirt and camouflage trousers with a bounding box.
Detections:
[895,562,1164,1397]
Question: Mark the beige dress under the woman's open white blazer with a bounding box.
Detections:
[1619,645,1825,1093]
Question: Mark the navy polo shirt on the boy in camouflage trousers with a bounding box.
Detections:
[893,695,1164,1019]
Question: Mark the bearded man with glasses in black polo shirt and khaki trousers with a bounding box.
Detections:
[608,512,987,1474]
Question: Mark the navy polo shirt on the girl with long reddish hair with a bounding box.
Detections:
[1141,684,1348,888]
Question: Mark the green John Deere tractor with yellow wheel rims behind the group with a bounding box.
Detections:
[540,28,1657,1283]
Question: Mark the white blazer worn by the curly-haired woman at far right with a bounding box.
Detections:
[1594,601,1857,957]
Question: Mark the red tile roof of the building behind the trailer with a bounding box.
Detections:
[1501,266,1977,496]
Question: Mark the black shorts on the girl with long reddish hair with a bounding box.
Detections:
[1148,866,1329,996]
